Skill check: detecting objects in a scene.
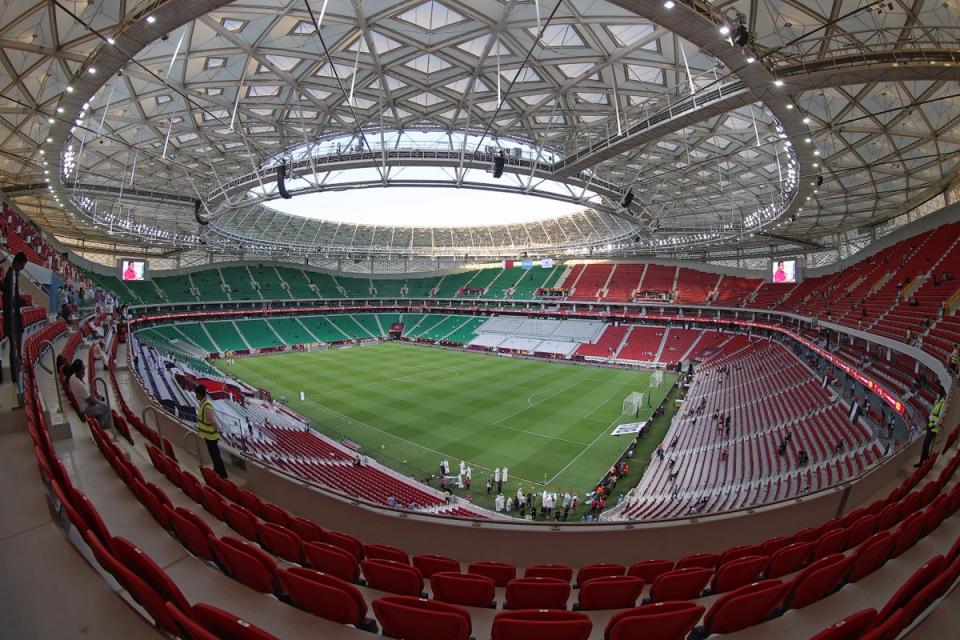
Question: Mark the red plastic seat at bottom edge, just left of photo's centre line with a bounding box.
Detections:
[373,596,472,640]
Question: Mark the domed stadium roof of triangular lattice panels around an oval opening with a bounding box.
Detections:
[0,0,960,256]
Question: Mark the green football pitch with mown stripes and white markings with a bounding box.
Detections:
[218,342,675,504]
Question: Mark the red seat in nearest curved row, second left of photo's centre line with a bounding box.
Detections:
[277,567,369,628]
